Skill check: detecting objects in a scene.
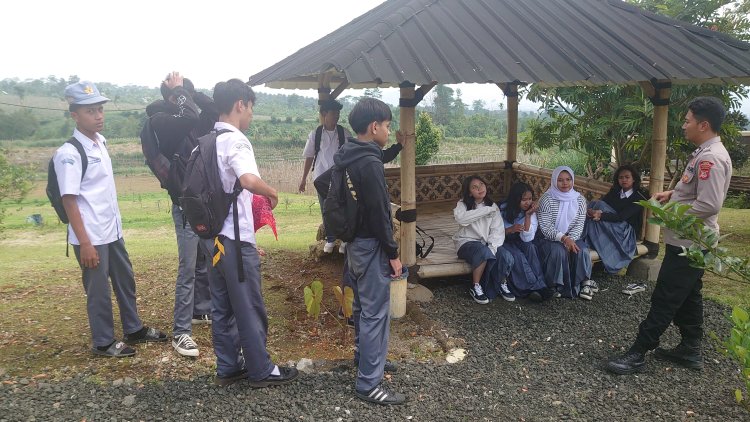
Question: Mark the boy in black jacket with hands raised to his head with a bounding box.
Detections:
[141,72,219,357]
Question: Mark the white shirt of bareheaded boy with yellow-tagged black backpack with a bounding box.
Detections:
[214,122,260,245]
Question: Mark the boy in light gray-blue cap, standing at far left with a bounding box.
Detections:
[50,81,167,357]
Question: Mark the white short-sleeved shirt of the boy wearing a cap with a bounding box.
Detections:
[53,129,122,246]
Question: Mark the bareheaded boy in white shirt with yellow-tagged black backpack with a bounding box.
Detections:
[200,79,298,387]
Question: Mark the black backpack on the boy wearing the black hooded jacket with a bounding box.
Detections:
[313,164,360,242]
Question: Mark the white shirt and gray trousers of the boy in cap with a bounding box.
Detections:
[53,129,143,347]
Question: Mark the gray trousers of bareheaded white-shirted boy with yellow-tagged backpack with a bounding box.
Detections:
[201,236,275,381]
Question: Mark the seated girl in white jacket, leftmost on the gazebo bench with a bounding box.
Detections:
[453,176,515,305]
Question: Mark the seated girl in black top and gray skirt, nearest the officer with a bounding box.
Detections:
[585,165,648,274]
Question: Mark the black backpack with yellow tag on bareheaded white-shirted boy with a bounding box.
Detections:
[179,129,244,281]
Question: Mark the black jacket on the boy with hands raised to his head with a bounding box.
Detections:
[146,86,219,166]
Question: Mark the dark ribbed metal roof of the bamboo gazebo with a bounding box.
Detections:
[250,0,750,89]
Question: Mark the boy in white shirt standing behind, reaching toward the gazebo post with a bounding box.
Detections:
[299,100,351,253]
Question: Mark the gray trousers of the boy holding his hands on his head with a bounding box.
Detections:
[172,204,211,336]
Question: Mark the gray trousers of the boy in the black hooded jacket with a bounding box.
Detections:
[346,237,393,391]
